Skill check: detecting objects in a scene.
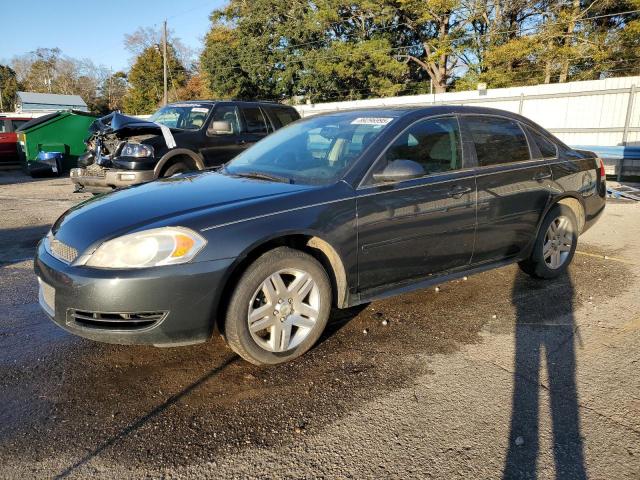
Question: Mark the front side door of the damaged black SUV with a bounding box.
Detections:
[200,103,246,167]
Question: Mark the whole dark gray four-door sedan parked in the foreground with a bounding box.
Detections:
[35,106,606,365]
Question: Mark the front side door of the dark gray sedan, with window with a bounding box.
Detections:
[357,116,476,290]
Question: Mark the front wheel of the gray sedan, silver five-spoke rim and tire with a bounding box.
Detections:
[224,247,332,365]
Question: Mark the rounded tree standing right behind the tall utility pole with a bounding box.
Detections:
[123,45,187,115]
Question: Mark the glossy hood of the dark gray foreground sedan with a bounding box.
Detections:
[52,172,318,252]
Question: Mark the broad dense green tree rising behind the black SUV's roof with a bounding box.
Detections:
[200,0,407,99]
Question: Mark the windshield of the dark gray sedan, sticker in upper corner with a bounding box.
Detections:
[222,112,396,184]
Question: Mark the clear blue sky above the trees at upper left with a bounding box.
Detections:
[0,0,226,70]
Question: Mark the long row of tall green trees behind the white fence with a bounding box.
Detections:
[200,0,640,101]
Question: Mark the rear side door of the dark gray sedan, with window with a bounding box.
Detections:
[461,115,551,264]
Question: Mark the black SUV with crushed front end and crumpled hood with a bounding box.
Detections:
[70,101,300,193]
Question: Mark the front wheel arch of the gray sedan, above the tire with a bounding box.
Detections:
[215,232,348,332]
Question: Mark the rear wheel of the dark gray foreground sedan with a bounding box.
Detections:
[519,205,578,278]
